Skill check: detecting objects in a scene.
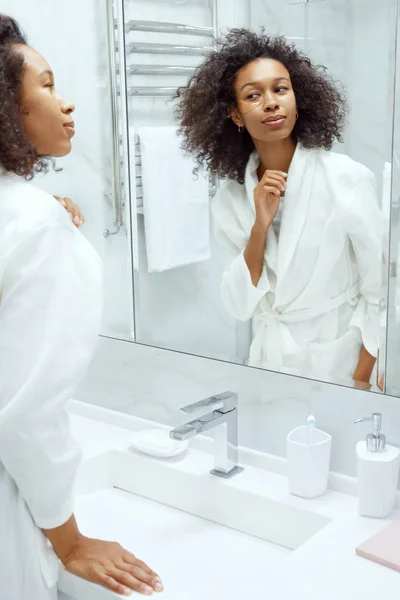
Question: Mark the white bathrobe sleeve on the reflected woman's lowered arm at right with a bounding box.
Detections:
[345,169,385,357]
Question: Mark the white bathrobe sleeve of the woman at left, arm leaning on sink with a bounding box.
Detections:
[0,222,101,529]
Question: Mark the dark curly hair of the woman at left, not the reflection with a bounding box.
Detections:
[0,14,54,179]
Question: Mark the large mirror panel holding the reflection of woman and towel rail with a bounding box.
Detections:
[103,0,400,392]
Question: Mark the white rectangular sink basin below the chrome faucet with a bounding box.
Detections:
[59,440,330,600]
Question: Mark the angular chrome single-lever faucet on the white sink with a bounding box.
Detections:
[169,392,243,479]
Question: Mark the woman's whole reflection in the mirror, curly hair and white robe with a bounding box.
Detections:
[177,29,383,387]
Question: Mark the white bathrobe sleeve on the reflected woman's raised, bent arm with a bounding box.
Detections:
[212,182,270,321]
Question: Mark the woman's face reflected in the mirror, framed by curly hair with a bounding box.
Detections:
[231,58,297,142]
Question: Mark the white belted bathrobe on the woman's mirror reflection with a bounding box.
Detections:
[213,144,383,384]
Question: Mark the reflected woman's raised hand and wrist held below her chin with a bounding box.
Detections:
[254,169,287,232]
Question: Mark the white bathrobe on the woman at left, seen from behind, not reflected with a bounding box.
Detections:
[0,173,102,600]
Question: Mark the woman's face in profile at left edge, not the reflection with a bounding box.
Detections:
[16,44,75,157]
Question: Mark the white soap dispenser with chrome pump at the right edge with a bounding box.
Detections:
[354,413,400,518]
